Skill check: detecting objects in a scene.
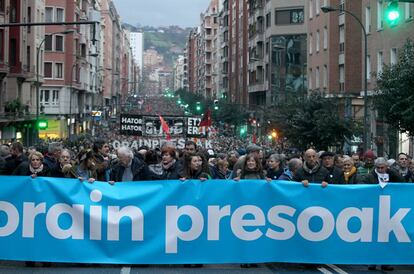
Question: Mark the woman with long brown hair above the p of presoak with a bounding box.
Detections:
[181,153,211,181]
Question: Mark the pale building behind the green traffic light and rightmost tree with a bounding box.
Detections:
[361,0,414,157]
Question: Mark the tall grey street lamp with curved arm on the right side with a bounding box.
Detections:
[321,6,369,151]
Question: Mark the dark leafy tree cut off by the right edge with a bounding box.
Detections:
[374,40,414,136]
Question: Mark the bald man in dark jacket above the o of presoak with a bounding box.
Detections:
[294,149,329,187]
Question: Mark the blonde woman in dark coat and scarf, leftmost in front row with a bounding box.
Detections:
[13,151,50,178]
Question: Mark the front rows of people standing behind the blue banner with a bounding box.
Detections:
[0,139,414,270]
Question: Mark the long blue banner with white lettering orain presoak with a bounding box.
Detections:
[0,177,414,264]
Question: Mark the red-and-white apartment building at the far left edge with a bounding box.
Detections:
[0,0,44,143]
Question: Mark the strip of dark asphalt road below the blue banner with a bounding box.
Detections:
[0,261,414,274]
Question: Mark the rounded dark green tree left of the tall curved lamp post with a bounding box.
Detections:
[272,95,354,150]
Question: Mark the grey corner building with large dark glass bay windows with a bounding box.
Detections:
[249,0,307,105]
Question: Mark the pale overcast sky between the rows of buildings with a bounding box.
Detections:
[114,0,210,27]
